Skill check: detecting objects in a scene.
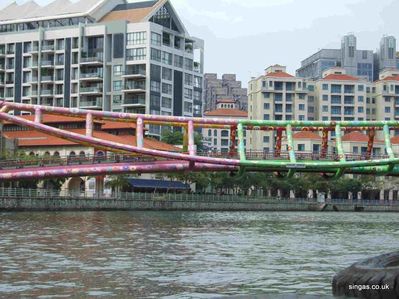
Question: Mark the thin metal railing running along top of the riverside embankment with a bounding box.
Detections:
[0,188,399,206]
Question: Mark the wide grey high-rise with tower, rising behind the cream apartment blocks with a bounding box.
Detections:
[296,34,374,81]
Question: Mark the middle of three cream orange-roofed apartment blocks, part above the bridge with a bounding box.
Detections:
[315,67,368,121]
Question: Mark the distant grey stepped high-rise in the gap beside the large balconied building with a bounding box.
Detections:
[204,74,248,111]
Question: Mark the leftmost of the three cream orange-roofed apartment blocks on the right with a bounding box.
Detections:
[248,65,315,152]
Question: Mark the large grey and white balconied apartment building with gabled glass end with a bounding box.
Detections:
[0,0,204,136]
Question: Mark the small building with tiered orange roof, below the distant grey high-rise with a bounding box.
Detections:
[202,98,248,153]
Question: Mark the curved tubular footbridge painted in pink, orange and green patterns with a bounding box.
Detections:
[0,101,399,180]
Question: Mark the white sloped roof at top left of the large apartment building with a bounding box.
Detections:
[0,0,114,24]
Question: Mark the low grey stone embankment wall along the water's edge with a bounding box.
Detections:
[0,196,399,212]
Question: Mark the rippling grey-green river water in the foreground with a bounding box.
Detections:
[0,212,399,298]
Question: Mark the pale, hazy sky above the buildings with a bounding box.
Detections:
[0,0,399,86]
